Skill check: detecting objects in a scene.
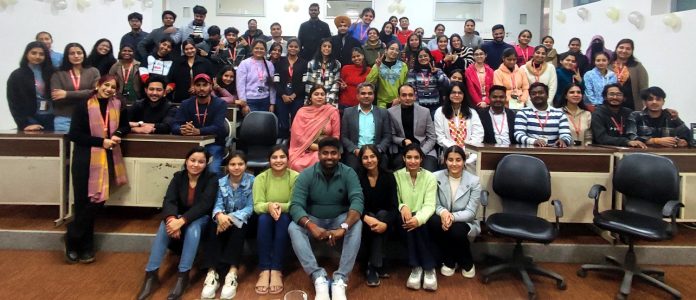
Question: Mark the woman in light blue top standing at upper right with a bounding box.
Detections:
[583,52,617,112]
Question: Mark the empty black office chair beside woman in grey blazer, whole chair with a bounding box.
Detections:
[481,154,566,299]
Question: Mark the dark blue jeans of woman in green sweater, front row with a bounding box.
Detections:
[256,213,292,271]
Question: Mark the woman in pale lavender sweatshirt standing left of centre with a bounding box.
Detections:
[236,40,276,112]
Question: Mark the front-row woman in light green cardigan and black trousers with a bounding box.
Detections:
[394,143,437,291]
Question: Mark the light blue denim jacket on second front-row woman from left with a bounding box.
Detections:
[213,173,254,228]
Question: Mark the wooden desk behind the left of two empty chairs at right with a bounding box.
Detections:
[466,144,614,223]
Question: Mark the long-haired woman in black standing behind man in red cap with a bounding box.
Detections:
[166,40,215,103]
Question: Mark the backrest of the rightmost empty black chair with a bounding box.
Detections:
[613,153,679,219]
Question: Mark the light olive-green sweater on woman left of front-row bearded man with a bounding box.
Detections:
[252,169,299,214]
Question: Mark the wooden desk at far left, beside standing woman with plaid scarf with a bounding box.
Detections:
[0,130,68,224]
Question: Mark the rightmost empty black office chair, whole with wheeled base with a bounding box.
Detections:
[577,153,684,299]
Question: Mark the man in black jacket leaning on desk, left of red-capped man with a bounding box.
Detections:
[128,75,176,134]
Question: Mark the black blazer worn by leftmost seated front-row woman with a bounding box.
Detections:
[162,170,218,223]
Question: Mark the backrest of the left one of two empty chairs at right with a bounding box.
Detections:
[493,154,551,216]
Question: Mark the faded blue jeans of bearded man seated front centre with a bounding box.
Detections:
[288,213,362,282]
